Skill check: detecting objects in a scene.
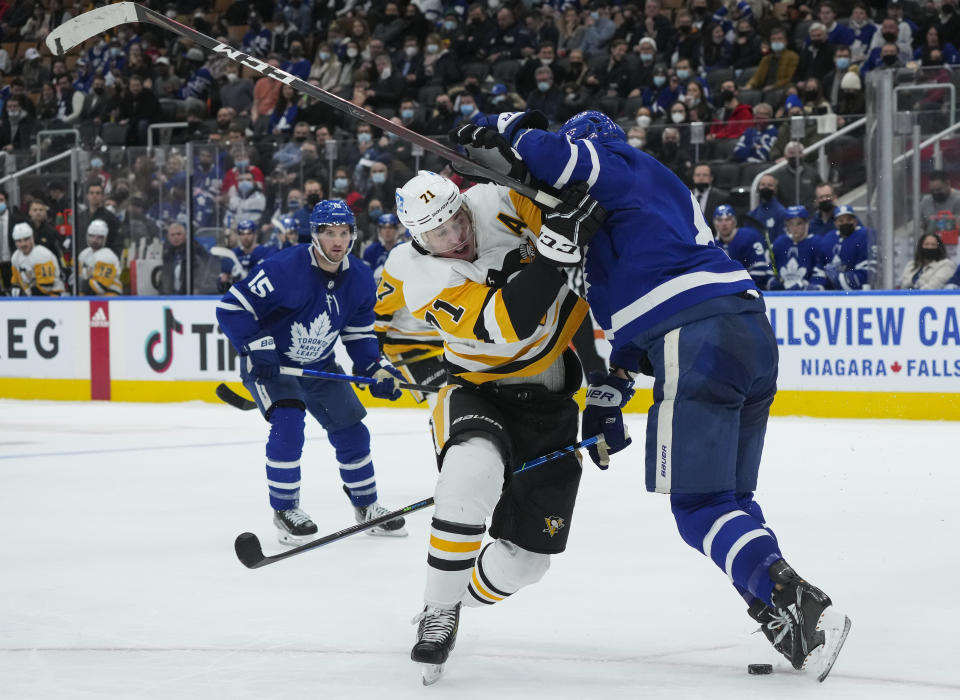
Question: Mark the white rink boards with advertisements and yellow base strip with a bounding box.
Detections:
[0,292,960,420]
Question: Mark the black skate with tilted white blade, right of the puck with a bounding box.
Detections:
[751,559,850,681]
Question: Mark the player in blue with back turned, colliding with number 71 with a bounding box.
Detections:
[456,111,850,680]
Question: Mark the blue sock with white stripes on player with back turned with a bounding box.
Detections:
[670,491,783,605]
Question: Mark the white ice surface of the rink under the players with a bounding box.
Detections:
[0,401,960,700]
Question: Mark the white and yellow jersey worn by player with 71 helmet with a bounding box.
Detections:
[377,184,587,384]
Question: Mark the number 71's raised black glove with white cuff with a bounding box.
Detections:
[537,183,607,267]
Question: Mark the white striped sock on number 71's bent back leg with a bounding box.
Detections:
[463,540,550,607]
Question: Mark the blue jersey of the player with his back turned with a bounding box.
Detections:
[510,125,756,350]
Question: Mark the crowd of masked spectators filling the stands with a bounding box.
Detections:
[0,0,960,289]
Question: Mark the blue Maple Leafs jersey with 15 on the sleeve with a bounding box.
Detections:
[217,245,380,369]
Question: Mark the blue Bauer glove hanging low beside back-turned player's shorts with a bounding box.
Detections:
[581,372,633,469]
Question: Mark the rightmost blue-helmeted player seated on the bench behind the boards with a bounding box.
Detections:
[810,204,877,290]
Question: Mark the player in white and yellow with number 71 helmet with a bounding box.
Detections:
[378,171,603,684]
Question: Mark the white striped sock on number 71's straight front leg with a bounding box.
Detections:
[424,436,503,609]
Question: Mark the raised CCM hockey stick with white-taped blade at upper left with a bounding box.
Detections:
[46,2,560,208]
